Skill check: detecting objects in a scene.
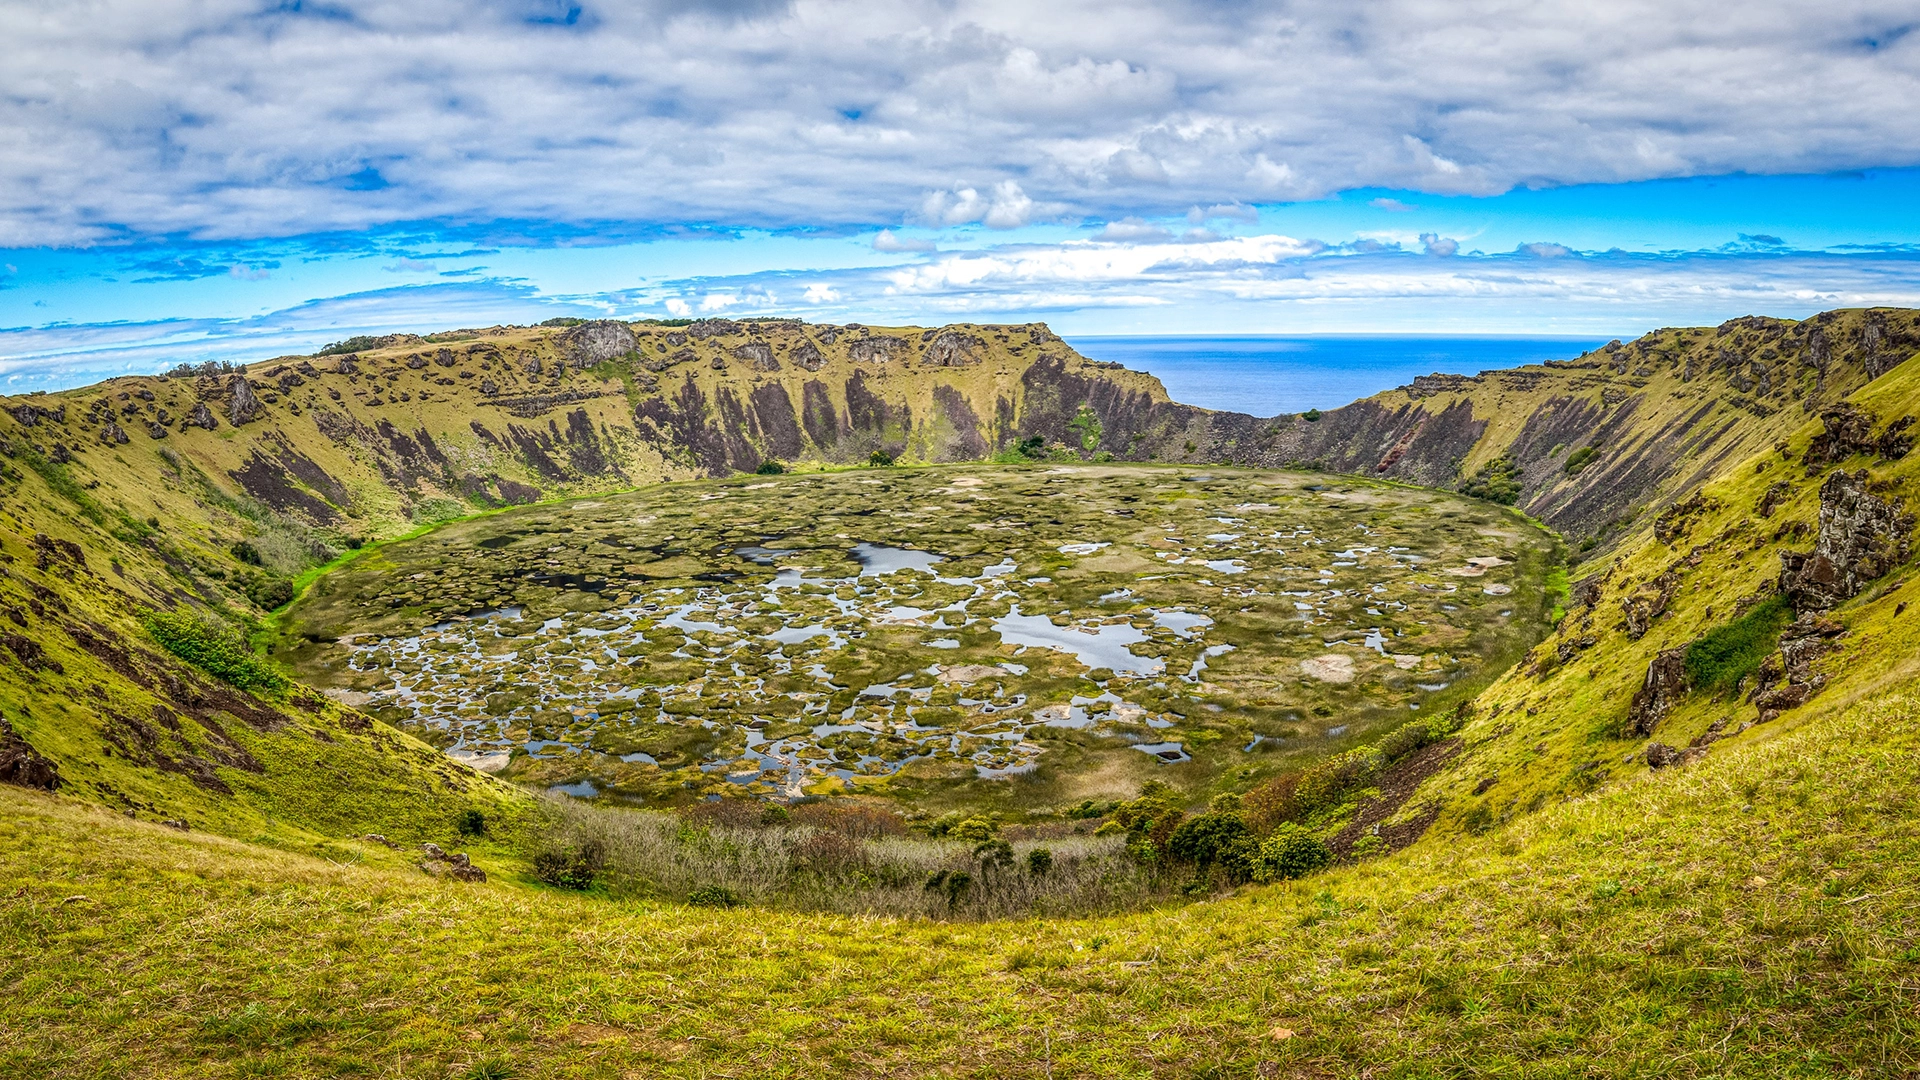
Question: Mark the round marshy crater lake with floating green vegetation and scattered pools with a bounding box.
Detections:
[280,465,1551,803]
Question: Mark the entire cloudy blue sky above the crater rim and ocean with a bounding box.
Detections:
[0,0,1920,386]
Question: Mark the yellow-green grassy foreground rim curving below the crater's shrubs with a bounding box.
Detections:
[0,676,1920,1078]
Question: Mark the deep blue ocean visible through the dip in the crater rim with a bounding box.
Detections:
[1066,334,1607,417]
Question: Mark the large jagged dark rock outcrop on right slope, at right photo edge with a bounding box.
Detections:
[1780,469,1912,613]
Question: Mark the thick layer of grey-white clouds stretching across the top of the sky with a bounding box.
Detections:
[0,0,1920,248]
